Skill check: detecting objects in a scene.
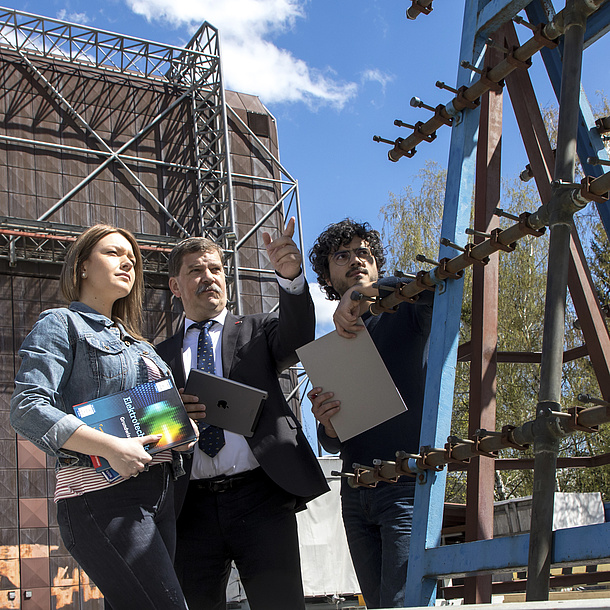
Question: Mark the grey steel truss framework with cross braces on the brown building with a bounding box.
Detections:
[0,8,303,312]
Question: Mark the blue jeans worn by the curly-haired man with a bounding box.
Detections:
[341,477,415,608]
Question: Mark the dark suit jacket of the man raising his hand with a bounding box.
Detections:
[156,288,329,507]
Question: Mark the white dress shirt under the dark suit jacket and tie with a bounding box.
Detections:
[182,273,305,479]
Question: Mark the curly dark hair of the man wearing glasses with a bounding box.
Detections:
[309,218,385,301]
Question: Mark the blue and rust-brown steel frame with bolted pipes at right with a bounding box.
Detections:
[358,0,610,606]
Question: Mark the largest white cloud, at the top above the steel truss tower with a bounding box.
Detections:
[127,0,357,108]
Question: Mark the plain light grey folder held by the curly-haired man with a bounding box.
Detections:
[297,329,407,442]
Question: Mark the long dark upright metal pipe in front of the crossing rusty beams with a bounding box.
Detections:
[526,0,586,602]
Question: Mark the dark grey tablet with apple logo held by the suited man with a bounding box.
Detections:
[184,369,267,436]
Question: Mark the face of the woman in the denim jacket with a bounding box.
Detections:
[80,233,136,313]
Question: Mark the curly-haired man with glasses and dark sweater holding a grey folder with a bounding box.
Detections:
[308,218,433,608]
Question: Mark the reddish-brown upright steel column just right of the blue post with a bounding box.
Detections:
[464,34,503,604]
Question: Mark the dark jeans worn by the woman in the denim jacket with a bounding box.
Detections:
[57,462,187,610]
